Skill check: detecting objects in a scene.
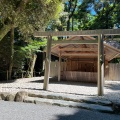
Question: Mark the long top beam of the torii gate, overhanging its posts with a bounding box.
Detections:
[34,29,120,37]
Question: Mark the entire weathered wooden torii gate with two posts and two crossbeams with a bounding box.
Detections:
[34,29,120,96]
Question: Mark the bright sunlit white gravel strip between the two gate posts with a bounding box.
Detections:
[49,81,97,95]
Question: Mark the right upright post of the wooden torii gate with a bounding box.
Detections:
[98,34,104,96]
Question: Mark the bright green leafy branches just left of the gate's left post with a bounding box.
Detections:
[14,39,46,70]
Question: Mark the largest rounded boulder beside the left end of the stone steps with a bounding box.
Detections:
[15,91,28,102]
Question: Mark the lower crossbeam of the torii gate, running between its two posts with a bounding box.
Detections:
[52,40,98,44]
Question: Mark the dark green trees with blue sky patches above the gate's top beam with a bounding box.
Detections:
[48,0,120,31]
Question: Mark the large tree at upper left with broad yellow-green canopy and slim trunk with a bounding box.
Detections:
[0,0,61,79]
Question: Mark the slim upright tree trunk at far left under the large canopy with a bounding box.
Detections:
[9,24,14,80]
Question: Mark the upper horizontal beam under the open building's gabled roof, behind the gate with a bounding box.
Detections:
[59,47,98,52]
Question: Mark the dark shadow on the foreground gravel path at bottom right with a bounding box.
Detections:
[56,109,120,120]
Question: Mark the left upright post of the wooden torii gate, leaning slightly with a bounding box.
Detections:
[43,36,52,90]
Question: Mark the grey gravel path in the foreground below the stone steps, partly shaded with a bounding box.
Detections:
[0,101,120,120]
